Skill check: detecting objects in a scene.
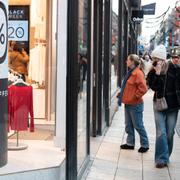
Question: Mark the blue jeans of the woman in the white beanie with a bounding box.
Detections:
[154,109,178,163]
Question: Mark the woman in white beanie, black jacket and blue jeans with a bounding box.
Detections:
[147,45,180,168]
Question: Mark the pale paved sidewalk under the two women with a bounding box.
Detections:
[85,91,180,180]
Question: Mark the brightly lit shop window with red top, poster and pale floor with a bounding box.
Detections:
[0,0,65,179]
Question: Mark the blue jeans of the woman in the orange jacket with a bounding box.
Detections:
[125,103,149,148]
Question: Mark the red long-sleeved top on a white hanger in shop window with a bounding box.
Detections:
[8,82,34,132]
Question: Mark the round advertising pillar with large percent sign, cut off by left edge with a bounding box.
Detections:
[0,0,8,167]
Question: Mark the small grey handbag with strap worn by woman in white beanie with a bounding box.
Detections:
[154,75,168,111]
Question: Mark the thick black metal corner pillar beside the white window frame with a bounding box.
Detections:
[66,0,79,180]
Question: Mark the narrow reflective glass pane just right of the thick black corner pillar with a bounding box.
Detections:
[77,0,87,169]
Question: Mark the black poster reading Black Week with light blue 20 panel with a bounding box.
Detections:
[8,5,29,53]
